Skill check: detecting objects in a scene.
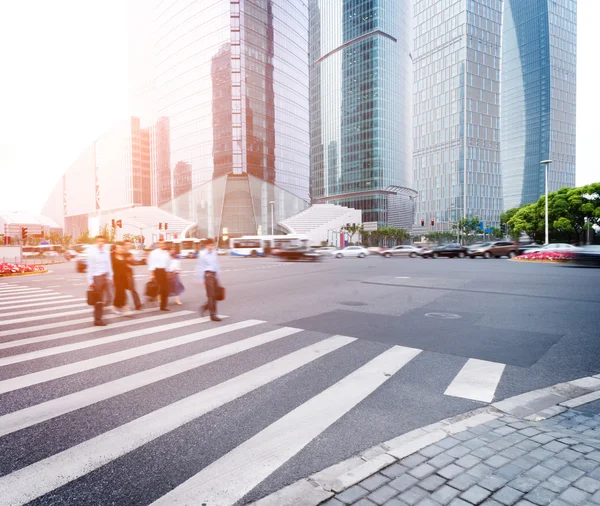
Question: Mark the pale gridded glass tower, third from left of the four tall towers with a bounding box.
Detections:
[413,0,503,232]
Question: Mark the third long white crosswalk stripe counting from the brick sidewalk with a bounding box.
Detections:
[0,327,303,437]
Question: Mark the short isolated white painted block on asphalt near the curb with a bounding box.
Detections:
[444,358,506,402]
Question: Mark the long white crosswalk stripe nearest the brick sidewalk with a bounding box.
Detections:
[152,346,421,506]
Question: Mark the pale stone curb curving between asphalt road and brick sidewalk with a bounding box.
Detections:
[250,374,600,506]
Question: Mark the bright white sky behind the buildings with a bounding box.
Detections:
[0,0,600,212]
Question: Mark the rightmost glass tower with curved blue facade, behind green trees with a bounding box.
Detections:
[502,0,577,209]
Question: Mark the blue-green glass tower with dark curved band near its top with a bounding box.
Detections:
[309,0,412,224]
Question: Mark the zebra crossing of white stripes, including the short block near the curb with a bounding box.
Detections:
[0,283,505,506]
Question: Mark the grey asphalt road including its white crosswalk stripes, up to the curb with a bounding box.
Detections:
[0,257,600,506]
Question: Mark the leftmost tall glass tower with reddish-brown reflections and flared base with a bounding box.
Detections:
[154,0,310,237]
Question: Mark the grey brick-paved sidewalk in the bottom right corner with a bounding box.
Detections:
[322,401,600,506]
